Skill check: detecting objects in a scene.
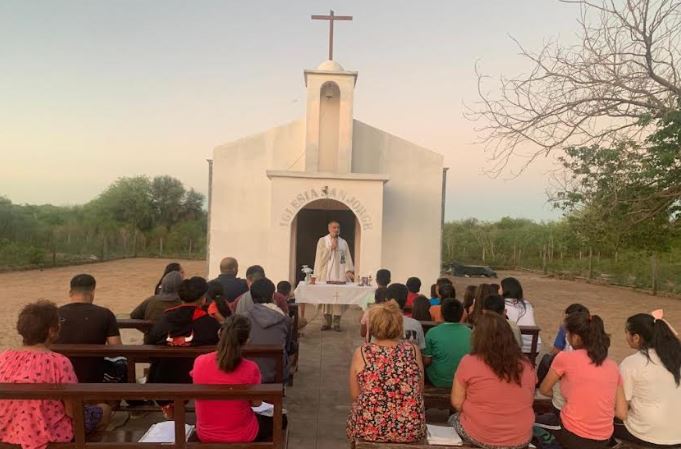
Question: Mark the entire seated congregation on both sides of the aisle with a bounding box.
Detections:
[0,258,681,449]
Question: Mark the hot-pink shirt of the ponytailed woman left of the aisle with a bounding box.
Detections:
[190,352,260,443]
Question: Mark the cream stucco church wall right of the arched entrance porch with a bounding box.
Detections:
[353,120,443,292]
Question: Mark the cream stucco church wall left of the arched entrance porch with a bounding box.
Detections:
[209,120,305,278]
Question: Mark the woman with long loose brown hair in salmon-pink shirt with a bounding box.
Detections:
[450,313,537,449]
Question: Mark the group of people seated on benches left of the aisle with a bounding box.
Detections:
[0,258,294,449]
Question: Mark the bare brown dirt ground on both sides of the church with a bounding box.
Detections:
[0,259,681,361]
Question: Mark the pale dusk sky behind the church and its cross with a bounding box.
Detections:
[0,0,577,220]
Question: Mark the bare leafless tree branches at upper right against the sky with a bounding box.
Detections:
[467,0,681,174]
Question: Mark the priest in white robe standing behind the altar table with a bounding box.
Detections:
[314,220,355,332]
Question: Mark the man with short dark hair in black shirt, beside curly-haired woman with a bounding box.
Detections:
[56,274,121,383]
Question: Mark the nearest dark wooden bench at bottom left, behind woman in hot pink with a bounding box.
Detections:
[0,383,287,449]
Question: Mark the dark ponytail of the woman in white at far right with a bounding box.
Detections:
[626,313,681,386]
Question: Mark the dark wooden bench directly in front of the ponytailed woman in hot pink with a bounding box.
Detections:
[50,344,284,383]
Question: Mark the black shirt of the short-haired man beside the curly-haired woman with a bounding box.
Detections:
[57,302,121,383]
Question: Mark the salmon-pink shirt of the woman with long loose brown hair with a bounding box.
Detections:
[455,355,537,446]
